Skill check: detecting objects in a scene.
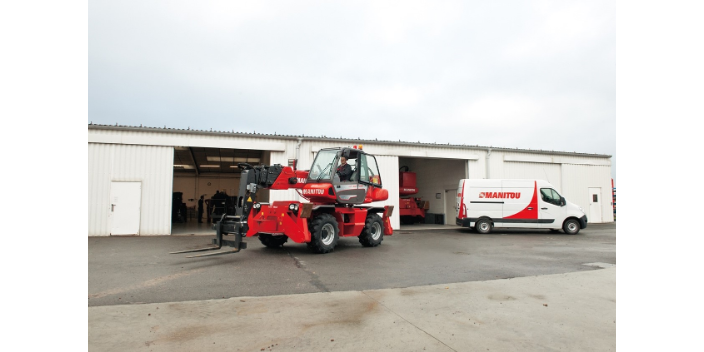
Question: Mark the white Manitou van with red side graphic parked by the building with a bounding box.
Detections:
[457,179,587,235]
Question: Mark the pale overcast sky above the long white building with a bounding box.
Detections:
[88,0,616,186]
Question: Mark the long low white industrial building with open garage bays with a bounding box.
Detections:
[88,124,615,237]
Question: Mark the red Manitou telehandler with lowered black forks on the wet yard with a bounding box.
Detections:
[171,146,394,258]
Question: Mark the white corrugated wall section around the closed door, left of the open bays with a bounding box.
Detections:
[88,143,174,236]
